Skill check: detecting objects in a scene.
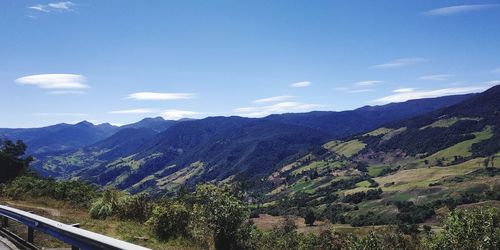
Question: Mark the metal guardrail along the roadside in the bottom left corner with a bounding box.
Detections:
[0,205,149,250]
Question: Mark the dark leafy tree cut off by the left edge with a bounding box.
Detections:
[0,140,33,183]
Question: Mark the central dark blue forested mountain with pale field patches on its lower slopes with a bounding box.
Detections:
[42,117,328,192]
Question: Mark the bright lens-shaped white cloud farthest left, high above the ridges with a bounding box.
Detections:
[16,74,89,90]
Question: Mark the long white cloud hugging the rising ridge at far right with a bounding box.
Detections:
[373,85,492,104]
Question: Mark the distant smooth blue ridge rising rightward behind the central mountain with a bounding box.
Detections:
[265,94,474,138]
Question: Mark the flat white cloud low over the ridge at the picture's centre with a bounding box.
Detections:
[234,102,324,117]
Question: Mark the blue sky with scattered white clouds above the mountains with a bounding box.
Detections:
[0,0,500,127]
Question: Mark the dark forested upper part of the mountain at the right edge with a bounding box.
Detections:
[359,86,500,156]
